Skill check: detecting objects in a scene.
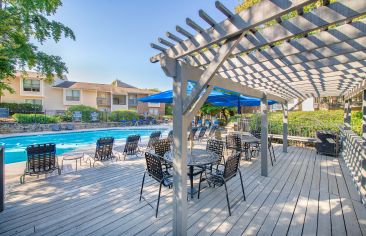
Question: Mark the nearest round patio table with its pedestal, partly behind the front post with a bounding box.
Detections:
[163,149,219,198]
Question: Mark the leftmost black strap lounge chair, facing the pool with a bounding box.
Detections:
[20,143,61,184]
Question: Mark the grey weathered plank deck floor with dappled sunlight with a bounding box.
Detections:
[0,146,366,235]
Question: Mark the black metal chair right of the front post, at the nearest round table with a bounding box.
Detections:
[198,153,246,216]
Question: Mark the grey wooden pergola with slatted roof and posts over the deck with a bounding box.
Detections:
[150,0,366,235]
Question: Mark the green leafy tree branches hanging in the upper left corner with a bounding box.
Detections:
[0,0,75,95]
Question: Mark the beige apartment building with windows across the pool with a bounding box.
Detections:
[1,72,165,115]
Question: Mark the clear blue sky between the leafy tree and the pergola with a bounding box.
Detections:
[36,0,238,90]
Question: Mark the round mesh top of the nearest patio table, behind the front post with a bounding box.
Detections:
[164,149,219,166]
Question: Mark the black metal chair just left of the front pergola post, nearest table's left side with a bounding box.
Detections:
[140,152,173,217]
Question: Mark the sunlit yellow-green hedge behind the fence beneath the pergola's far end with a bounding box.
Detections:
[250,110,362,137]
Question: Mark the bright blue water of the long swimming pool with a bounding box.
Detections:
[0,129,165,164]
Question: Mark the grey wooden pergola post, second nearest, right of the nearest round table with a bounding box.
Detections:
[261,94,268,177]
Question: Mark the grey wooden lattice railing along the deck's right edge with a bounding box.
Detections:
[340,127,366,203]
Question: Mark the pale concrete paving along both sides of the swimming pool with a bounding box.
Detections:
[0,124,172,186]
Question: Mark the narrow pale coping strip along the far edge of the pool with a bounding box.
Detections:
[0,124,171,139]
